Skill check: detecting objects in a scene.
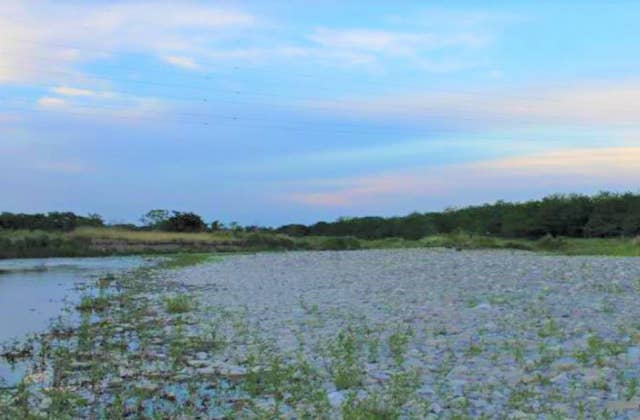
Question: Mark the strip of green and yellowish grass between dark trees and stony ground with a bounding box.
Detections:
[0,227,640,258]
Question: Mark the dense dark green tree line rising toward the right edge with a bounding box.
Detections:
[277,192,640,239]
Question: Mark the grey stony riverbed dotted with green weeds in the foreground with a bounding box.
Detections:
[0,249,640,419]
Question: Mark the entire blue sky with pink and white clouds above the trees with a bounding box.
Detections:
[0,0,640,226]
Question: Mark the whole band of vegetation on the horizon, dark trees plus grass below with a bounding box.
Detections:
[5,193,640,258]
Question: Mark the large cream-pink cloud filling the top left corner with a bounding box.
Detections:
[0,1,257,83]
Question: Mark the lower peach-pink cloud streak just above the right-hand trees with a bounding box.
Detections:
[286,147,640,208]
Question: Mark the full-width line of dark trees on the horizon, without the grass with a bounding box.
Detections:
[0,192,640,239]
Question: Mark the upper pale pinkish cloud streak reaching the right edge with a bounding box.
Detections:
[306,80,640,125]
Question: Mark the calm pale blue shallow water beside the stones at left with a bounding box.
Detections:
[0,257,149,381]
